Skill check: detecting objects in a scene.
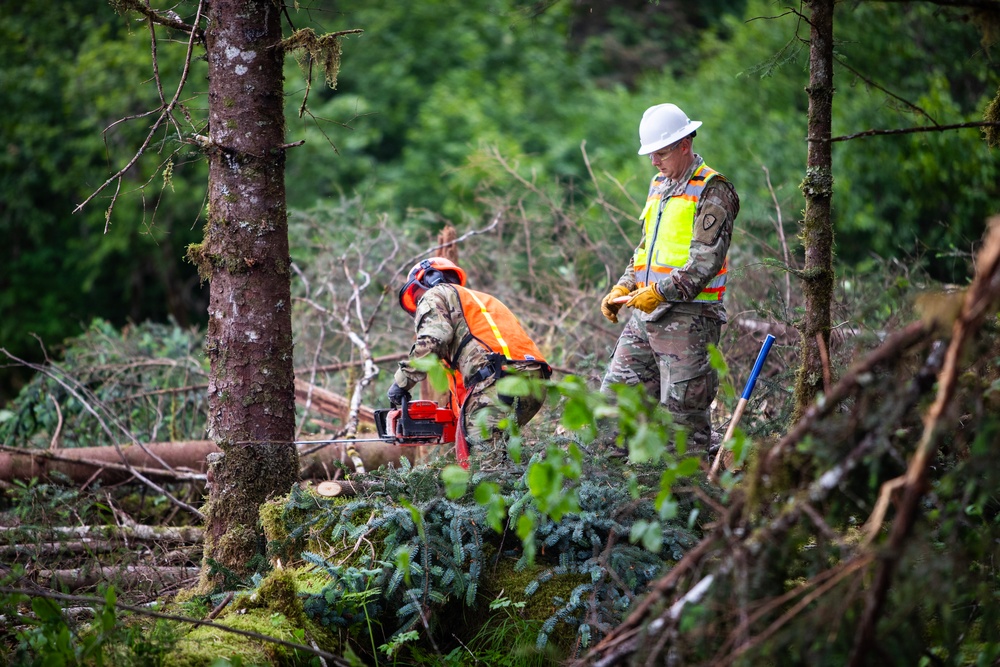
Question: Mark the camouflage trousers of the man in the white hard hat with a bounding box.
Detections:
[601,311,722,454]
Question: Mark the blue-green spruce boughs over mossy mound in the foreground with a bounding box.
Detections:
[271,454,697,664]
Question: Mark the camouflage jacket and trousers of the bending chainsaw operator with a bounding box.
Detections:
[393,284,548,466]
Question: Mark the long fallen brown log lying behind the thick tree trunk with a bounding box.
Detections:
[0,440,415,484]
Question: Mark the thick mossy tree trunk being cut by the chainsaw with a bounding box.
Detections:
[198,0,299,584]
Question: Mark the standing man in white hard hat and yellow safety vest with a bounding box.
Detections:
[601,104,740,453]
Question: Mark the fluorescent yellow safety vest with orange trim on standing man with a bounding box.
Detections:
[633,164,729,301]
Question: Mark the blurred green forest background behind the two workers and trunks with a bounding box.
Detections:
[0,0,1000,408]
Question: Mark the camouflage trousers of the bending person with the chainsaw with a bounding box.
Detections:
[463,372,545,468]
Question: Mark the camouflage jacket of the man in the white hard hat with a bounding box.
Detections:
[618,154,740,322]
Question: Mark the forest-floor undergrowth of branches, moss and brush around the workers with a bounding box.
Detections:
[0,201,1000,665]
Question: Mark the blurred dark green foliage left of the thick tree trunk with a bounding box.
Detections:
[0,0,207,395]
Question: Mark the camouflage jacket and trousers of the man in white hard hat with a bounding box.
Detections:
[601,154,740,453]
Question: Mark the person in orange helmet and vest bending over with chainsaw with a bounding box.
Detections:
[388,257,552,467]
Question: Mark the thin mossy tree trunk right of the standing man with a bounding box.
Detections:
[795,0,834,419]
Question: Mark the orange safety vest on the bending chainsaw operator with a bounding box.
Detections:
[446,285,548,423]
